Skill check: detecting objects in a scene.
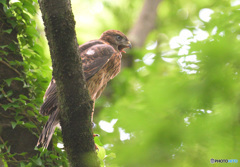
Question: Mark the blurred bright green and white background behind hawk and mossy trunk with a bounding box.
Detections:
[1,0,240,167]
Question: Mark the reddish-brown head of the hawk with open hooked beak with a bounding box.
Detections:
[100,30,132,53]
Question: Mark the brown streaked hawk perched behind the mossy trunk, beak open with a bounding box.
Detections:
[37,30,132,148]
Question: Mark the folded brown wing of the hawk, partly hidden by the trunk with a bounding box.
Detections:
[39,40,116,115]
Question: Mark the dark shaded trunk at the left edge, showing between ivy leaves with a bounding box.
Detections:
[0,3,37,167]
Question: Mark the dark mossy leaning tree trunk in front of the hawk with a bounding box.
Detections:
[39,0,99,167]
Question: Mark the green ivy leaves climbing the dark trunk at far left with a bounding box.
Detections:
[0,0,68,167]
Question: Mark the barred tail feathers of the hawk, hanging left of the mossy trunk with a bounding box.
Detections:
[37,109,59,148]
